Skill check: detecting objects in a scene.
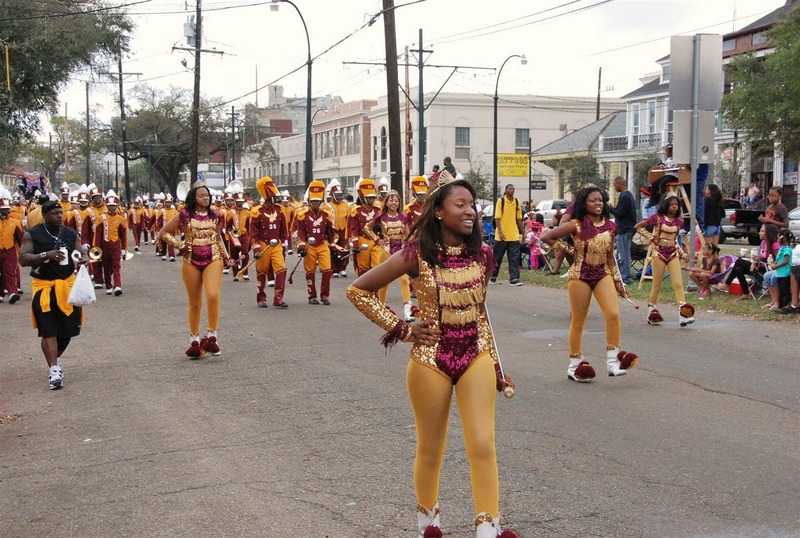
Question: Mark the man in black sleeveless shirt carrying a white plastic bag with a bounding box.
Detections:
[19,201,89,389]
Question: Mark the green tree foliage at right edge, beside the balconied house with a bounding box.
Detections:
[721,9,800,156]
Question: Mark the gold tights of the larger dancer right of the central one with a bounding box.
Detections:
[567,275,621,357]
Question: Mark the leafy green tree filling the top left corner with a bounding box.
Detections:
[0,0,132,164]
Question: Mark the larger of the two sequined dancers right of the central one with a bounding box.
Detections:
[541,185,638,383]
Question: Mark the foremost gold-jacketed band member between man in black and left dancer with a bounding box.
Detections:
[93,190,128,297]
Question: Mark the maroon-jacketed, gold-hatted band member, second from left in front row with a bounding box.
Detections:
[297,179,333,305]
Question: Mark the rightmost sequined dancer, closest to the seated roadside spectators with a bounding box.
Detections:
[634,193,694,327]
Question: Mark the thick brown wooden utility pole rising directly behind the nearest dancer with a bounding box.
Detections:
[383,0,405,201]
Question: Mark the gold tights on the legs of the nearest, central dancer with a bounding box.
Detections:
[406,353,500,515]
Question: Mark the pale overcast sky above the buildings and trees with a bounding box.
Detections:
[56,0,785,129]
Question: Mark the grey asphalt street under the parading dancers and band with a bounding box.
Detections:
[0,248,800,538]
